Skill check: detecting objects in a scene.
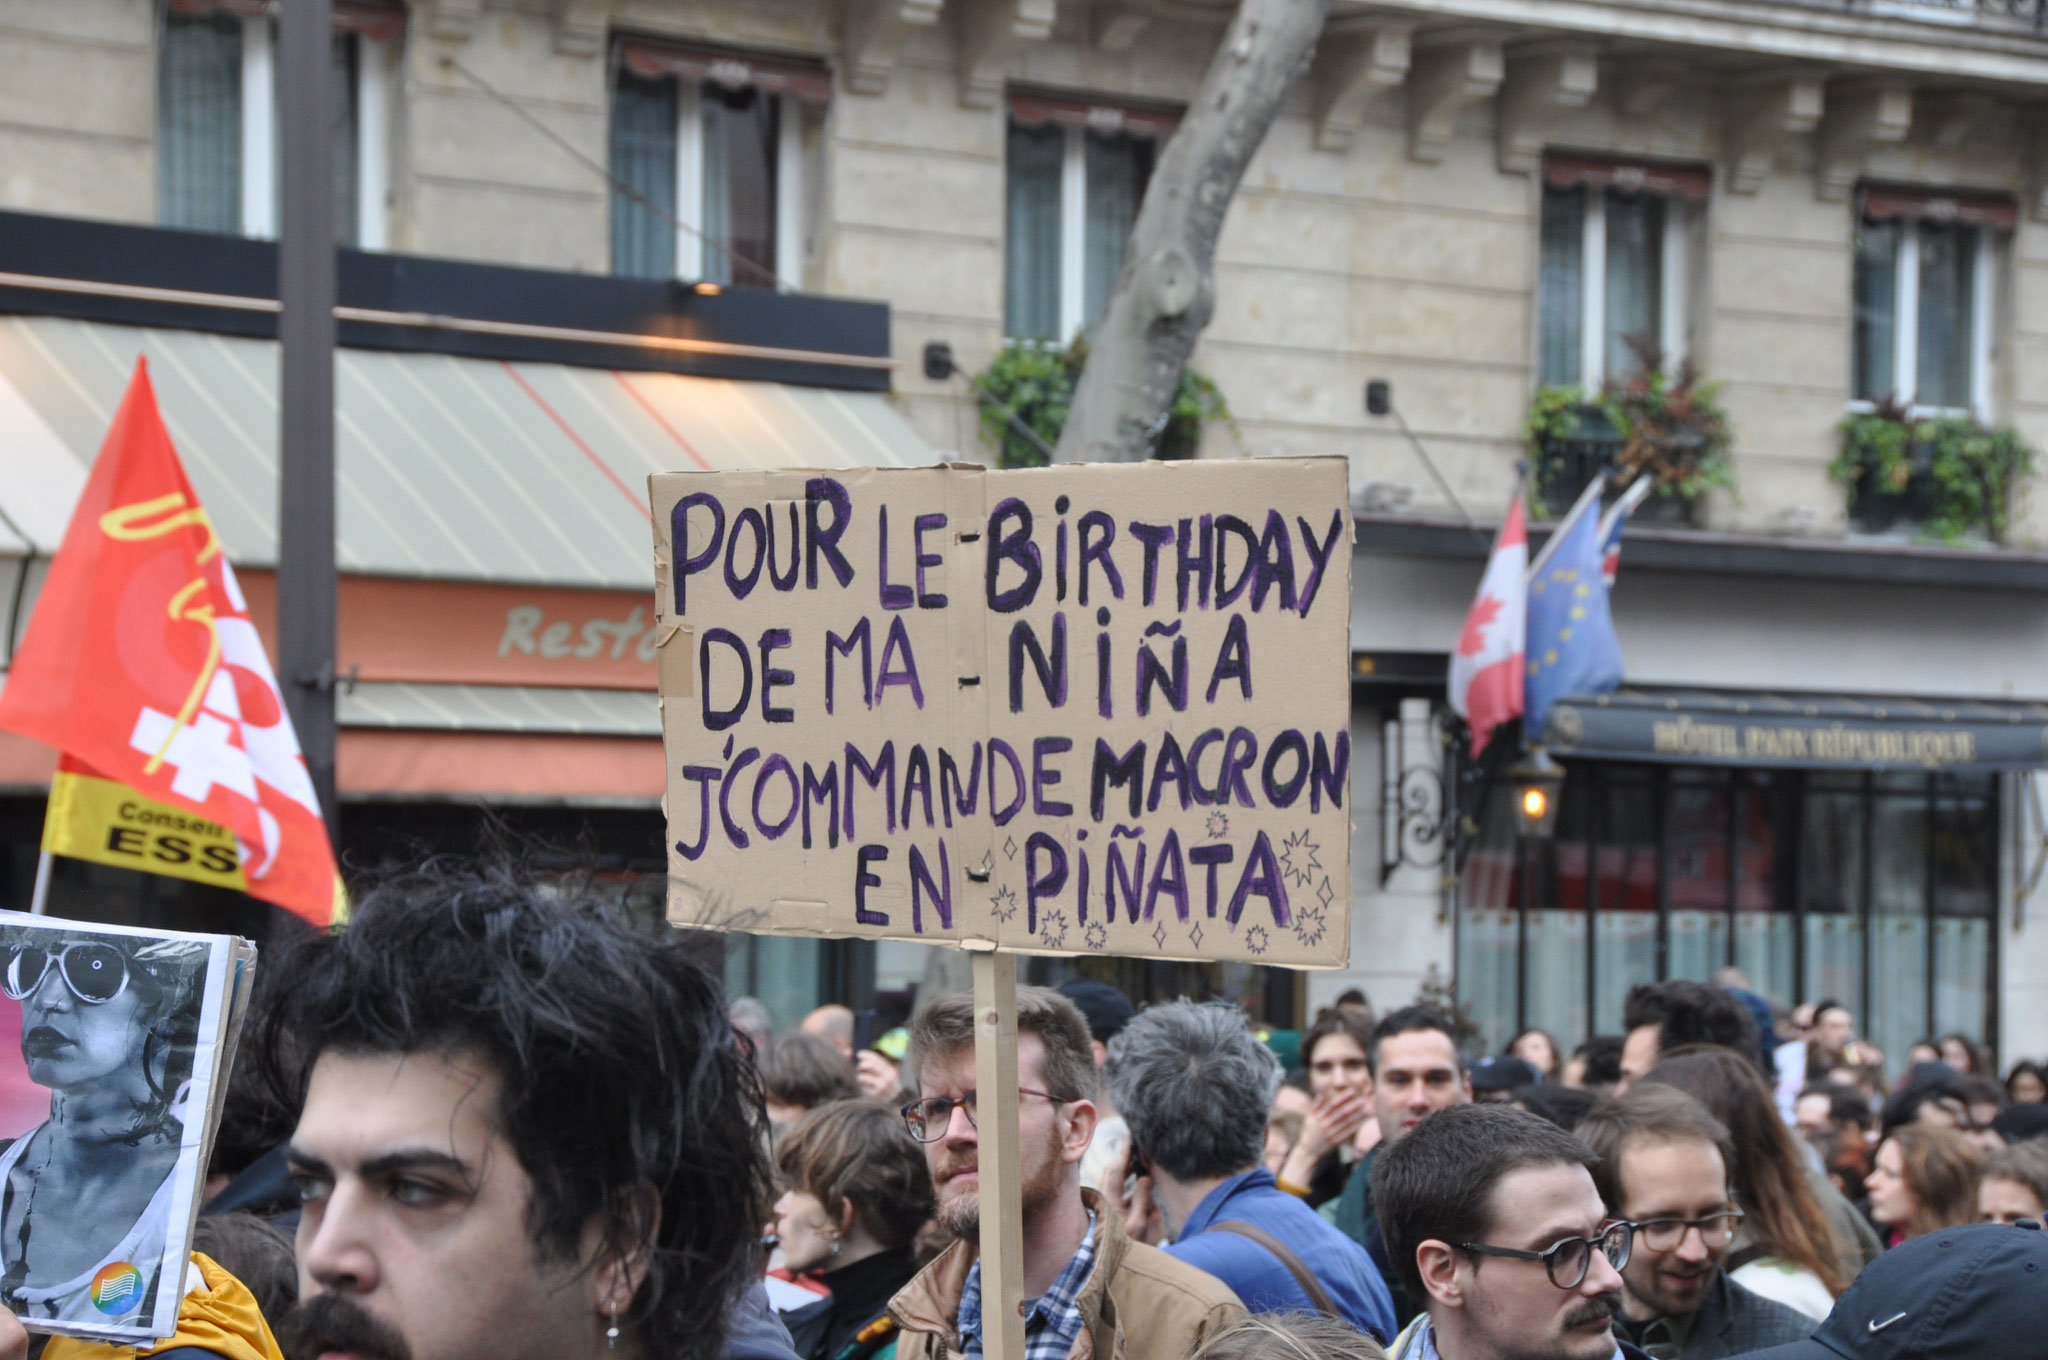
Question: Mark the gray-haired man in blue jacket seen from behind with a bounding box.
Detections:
[1104,1002,1395,1342]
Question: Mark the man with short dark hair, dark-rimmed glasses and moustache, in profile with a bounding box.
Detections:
[1372,1104,1645,1360]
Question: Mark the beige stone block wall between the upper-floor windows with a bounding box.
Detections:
[0,0,2048,543]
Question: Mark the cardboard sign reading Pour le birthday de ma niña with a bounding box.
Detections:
[649,459,1352,965]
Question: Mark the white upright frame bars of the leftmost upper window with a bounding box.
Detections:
[242,14,391,250]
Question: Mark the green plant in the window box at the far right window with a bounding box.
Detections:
[1827,399,2036,543]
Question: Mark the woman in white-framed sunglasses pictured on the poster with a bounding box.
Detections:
[0,930,205,1323]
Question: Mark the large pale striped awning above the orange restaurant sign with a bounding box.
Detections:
[0,315,938,590]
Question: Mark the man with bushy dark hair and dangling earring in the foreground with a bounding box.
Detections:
[254,873,788,1360]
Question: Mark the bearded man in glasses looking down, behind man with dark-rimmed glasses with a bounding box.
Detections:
[1577,1083,1815,1360]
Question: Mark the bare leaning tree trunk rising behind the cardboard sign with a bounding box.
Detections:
[1053,0,1329,463]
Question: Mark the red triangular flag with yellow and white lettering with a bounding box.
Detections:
[0,358,340,926]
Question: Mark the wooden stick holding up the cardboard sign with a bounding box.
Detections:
[973,948,1024,1360]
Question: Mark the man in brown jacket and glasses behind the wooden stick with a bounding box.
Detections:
[889,987,1245,1360]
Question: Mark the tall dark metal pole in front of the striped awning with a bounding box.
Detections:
[276,0,340,840]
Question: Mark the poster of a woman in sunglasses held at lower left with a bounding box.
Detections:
[0,911,256,1348]
